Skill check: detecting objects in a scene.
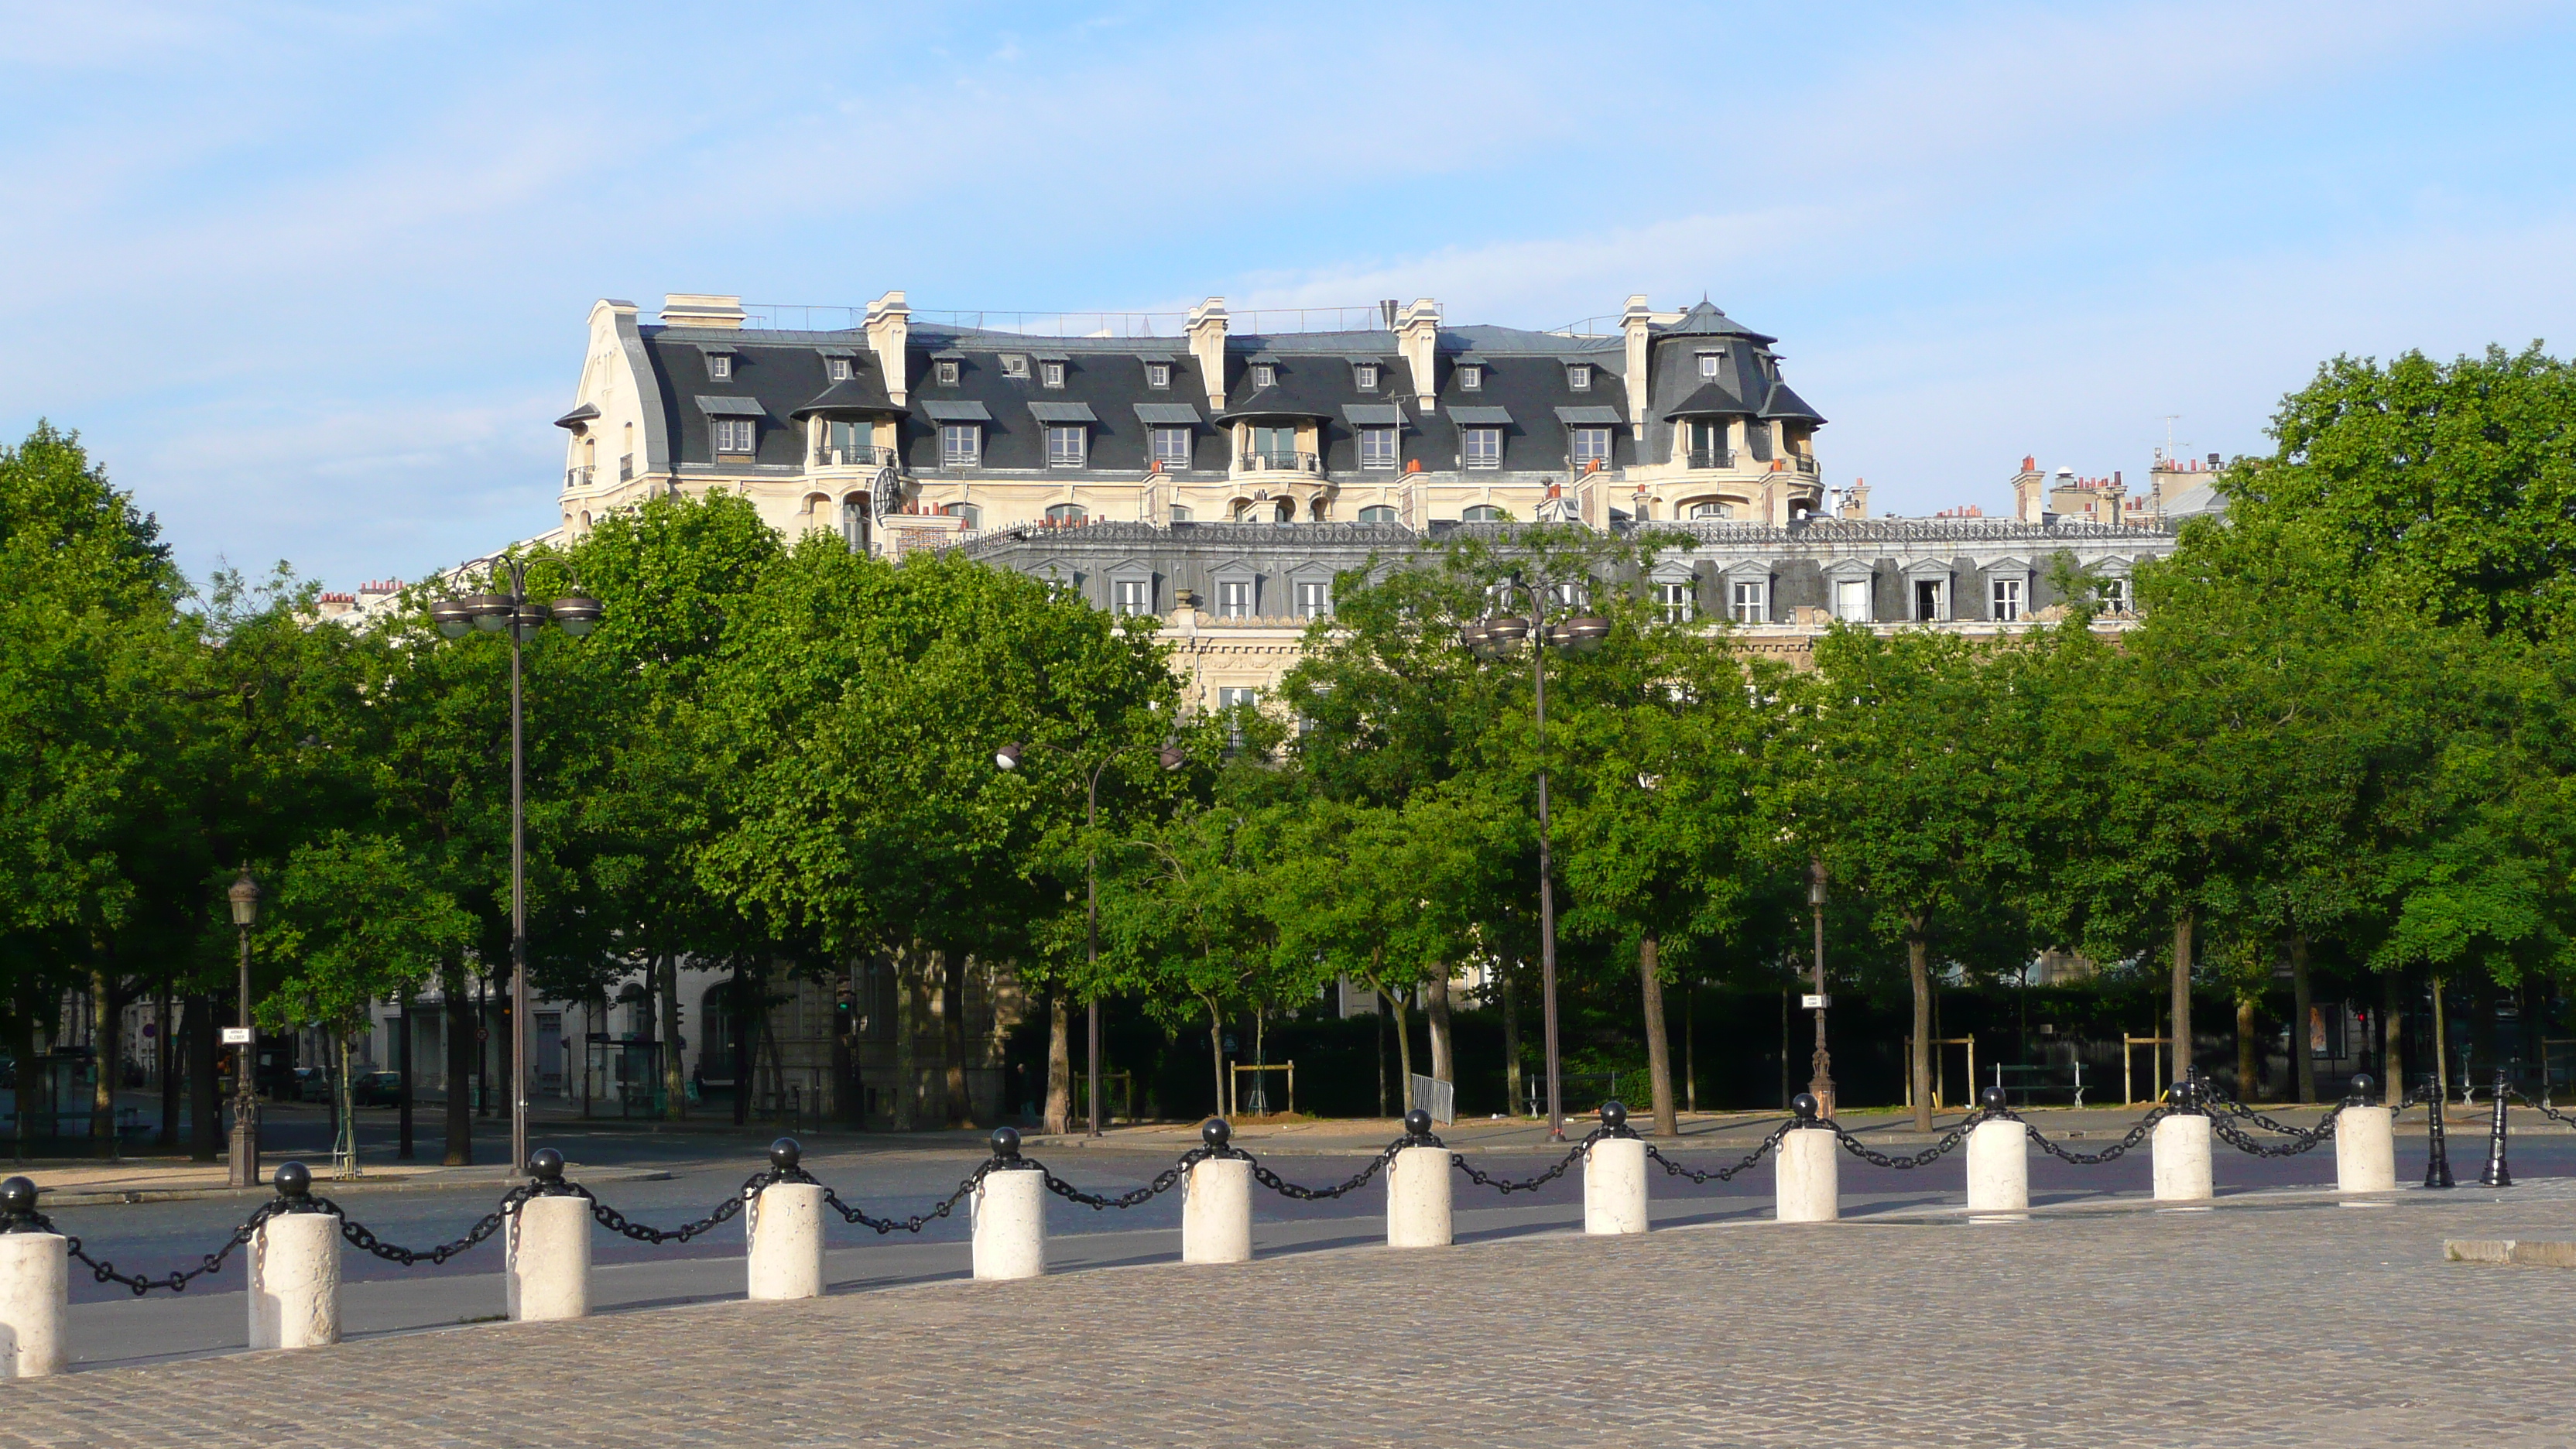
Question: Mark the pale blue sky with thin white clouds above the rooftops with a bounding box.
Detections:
[0,0,2576,587]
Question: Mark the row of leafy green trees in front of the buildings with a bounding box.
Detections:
[0,340,2576,1155]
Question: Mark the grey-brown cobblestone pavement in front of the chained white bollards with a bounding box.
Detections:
[0,1178,2576,1449]
